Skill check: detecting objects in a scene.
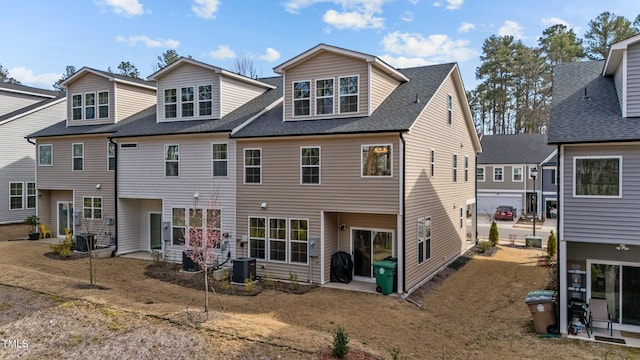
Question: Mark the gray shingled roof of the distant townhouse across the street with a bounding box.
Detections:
[478,134,555,164]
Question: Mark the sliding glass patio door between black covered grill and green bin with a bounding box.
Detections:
[351,229,393,280]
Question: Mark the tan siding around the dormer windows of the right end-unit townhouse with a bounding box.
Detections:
[283,52,369,120]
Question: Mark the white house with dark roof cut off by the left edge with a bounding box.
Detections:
[0,83,66,224]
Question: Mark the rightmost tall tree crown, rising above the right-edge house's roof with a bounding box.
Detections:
[584,11,638,60]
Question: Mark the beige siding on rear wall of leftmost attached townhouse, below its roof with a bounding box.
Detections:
[37,135,115,245]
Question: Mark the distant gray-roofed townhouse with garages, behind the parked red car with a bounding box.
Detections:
[476,134,556,216]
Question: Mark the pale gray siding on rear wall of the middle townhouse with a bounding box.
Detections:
[118,134,236,260]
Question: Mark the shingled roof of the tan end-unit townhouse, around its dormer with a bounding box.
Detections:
[232,63,455,138]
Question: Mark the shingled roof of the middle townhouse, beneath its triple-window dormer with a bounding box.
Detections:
[113,77,282,138]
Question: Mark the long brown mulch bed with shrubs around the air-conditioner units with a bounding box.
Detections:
[144,261,318,296]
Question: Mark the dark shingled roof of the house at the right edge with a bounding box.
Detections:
[549,60,640,144]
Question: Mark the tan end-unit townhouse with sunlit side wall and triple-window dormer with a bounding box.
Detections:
[231,44,480,294]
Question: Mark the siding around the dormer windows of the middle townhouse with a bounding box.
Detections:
[157,64,221,122]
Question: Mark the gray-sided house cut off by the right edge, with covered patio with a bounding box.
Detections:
[549,35,640,333]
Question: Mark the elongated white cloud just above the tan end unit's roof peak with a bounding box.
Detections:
[382,31,477,62]
